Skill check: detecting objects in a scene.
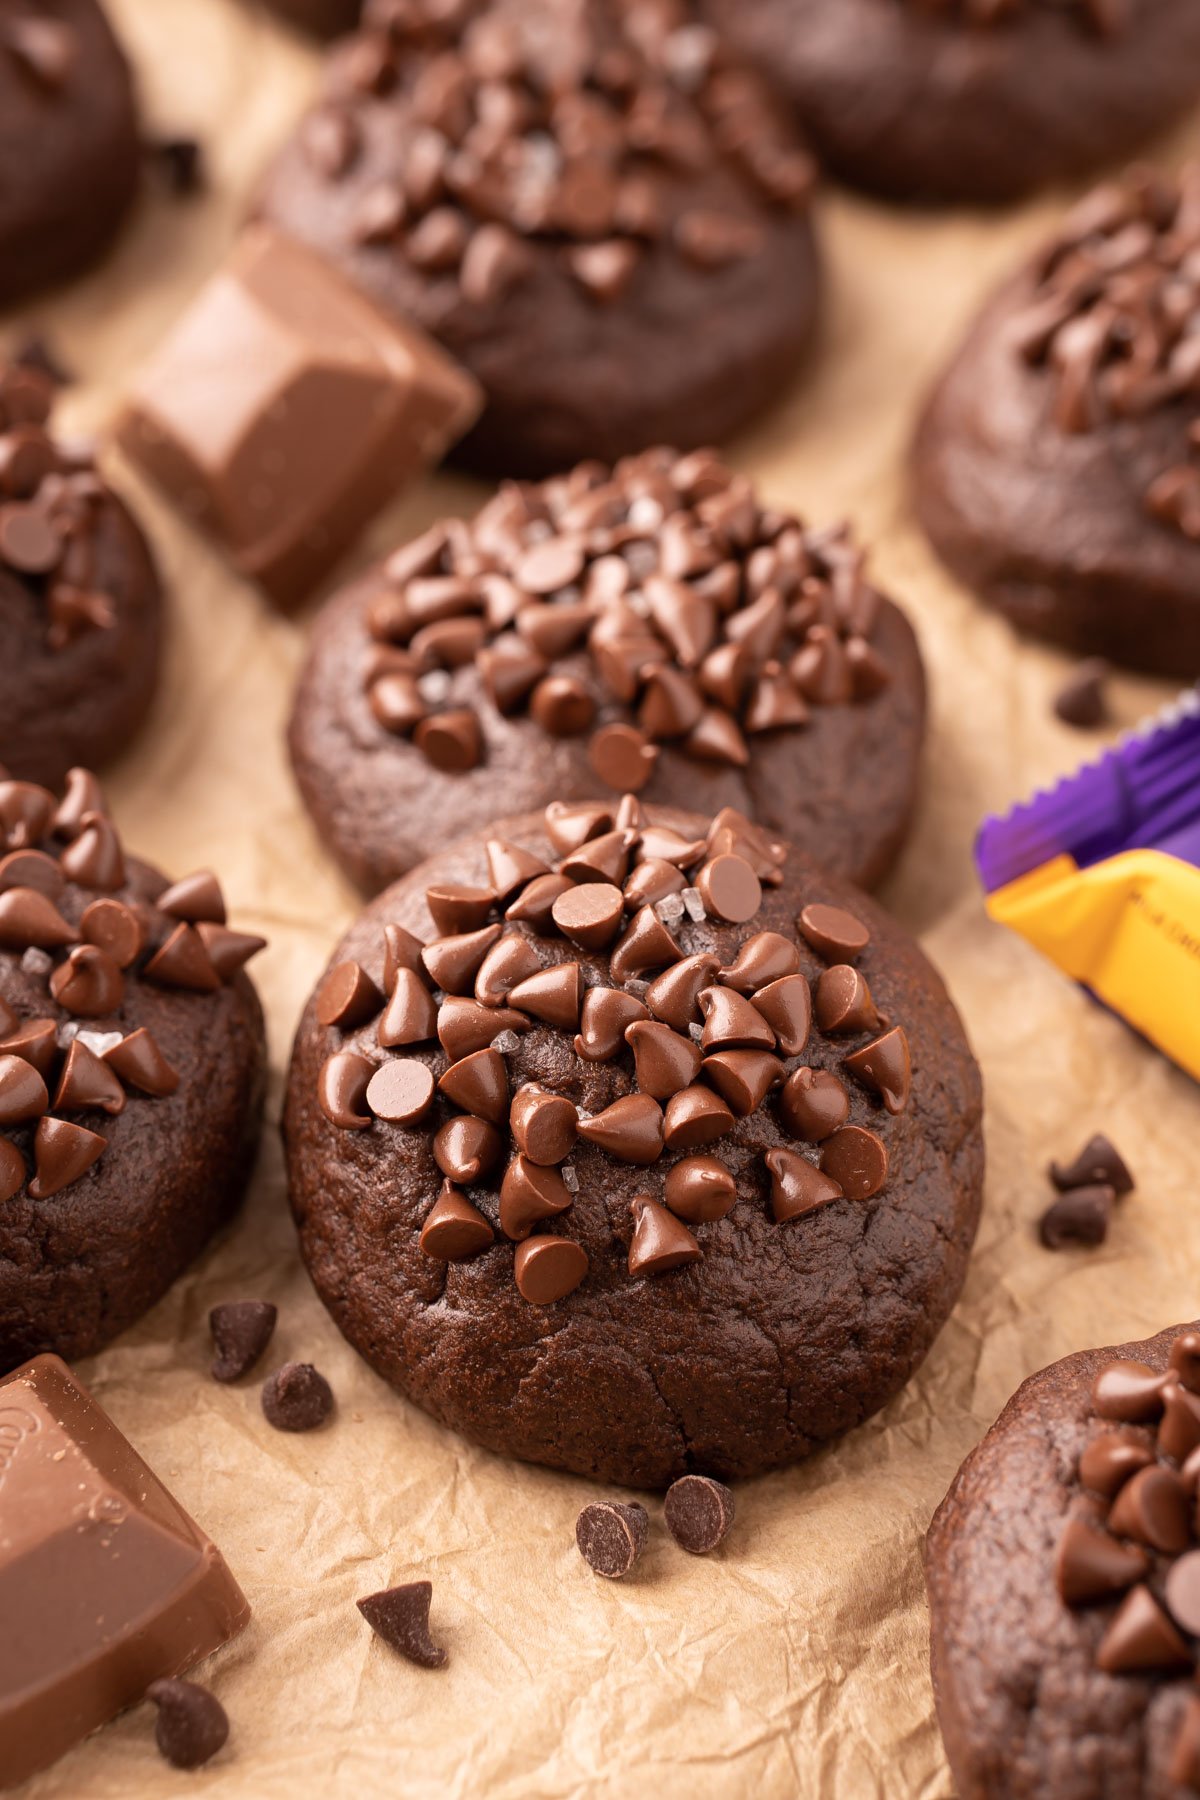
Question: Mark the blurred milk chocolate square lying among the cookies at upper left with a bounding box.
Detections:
[117,225,480,607]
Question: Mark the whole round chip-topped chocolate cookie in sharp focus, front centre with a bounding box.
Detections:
[284,796,982,1487]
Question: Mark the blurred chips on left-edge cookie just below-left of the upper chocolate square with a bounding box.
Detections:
[0,358,117,652]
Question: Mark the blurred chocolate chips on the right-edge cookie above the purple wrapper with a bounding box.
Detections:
[1013,164,1200,547]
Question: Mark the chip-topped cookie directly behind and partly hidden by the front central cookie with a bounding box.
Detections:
[290,450,925,893]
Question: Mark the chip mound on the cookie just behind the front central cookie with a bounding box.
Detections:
[363,450,889,781]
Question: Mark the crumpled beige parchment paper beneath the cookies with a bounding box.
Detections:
[5,0,1200,1800]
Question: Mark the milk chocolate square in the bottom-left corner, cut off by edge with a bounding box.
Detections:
[0,1355,250,1787]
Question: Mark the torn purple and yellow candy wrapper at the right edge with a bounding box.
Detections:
[977,689,1200,1080]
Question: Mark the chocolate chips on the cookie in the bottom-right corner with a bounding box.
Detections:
[1056,1330,1200,1791]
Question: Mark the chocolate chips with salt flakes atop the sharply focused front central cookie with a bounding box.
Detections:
[313,796,912,1305]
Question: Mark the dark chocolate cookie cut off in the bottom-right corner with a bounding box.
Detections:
[928,1327,1200,1800]
